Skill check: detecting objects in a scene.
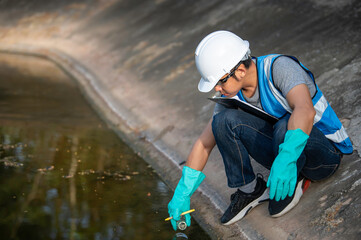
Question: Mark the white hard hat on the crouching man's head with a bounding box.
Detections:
[195,31,250,92]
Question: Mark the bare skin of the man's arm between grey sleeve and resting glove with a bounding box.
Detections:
[286,84,316,135]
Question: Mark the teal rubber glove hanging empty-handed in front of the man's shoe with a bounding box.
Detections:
[267,128,309,201]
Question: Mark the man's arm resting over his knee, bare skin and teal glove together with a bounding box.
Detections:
[267,84,316,201]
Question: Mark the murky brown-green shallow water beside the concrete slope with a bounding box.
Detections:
[0,55,210,239]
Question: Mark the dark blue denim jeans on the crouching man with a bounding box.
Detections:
[212,109,342,187]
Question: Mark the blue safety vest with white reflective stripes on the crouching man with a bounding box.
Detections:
[237,54,353,154]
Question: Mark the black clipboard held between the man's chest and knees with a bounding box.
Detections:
[208,97,278,124]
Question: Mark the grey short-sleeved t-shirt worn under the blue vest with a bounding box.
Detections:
[213,56,316,115]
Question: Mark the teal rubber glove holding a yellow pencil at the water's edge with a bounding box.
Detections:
[168,166,206,231]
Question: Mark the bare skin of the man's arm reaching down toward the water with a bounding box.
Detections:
[186,118,216,171]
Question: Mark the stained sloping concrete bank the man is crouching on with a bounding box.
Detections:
[0,0,361,239]
